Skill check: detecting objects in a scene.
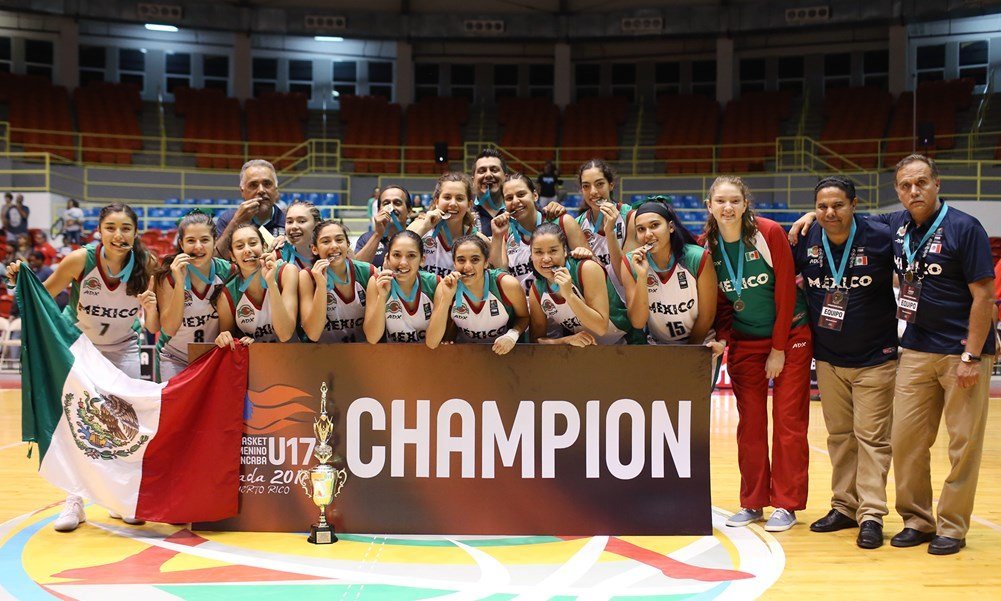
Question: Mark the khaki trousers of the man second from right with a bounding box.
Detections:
[817,361,897,524]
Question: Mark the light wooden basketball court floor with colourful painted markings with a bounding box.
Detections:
[0,390,1001,601]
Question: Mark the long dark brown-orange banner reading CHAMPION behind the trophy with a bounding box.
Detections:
[192,344,712,535]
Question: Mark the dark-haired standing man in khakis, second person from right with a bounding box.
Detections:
[793,176,897,549]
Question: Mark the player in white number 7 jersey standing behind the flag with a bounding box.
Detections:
[7,202,160,532]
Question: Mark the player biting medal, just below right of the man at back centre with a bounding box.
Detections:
[490,173,588,294]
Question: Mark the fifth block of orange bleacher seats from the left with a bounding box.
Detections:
[340,96,400,173]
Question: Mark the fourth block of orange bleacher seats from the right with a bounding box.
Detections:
[654,94,720,173]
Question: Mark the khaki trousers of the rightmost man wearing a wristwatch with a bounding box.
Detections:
[891,349,991,539]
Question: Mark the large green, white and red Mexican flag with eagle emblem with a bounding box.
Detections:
[16,268,248,523]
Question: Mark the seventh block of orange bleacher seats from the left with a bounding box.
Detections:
[497,97,560,172]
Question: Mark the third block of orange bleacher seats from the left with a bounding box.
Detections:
[174,87,243,169]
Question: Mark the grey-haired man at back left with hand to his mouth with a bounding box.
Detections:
[215,158,285,259]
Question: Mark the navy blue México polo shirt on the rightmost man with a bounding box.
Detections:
[871,206,995,355]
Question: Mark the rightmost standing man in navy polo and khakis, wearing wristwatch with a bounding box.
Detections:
[885,154,996,555]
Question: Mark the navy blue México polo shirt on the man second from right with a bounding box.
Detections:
[793,214,897,368]
